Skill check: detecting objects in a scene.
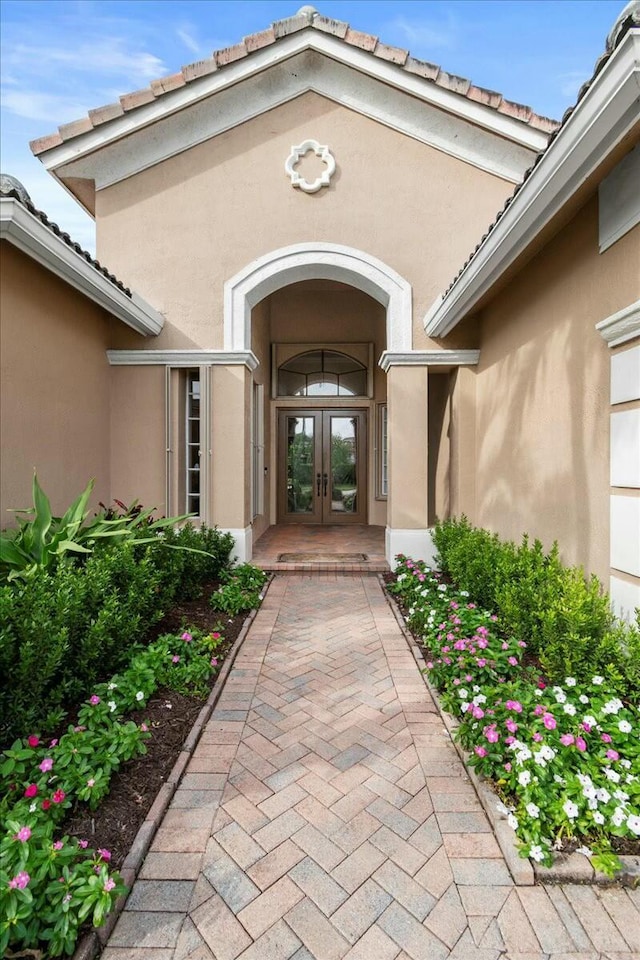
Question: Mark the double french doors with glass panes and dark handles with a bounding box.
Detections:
[278,408,367,523]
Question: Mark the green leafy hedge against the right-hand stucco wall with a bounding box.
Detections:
[434,516,640,696]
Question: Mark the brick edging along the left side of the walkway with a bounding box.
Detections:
[71,575,273,960]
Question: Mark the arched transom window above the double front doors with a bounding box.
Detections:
[278,350,367,397]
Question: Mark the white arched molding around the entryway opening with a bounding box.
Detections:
[224,242,412,351]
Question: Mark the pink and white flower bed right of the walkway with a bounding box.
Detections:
[389,557,640,875]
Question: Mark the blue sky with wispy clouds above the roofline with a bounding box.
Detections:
[0,0,624,249]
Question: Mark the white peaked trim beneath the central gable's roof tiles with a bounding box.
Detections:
[39,30,548,199]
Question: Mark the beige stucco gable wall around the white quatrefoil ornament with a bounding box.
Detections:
[96,93,512,348]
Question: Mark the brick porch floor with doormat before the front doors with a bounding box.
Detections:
[252,523,389,574]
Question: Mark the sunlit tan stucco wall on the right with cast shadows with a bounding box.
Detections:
[464,196,640,581]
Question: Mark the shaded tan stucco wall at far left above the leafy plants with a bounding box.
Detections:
[0,242,110,527]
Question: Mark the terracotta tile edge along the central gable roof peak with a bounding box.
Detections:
[31,6,558,156]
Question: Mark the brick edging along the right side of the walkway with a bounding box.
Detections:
[378,574,640,888]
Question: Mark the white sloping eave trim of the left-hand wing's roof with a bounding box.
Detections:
[0,197,164,337]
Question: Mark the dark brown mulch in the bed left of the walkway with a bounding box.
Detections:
[63,584,246,869]
